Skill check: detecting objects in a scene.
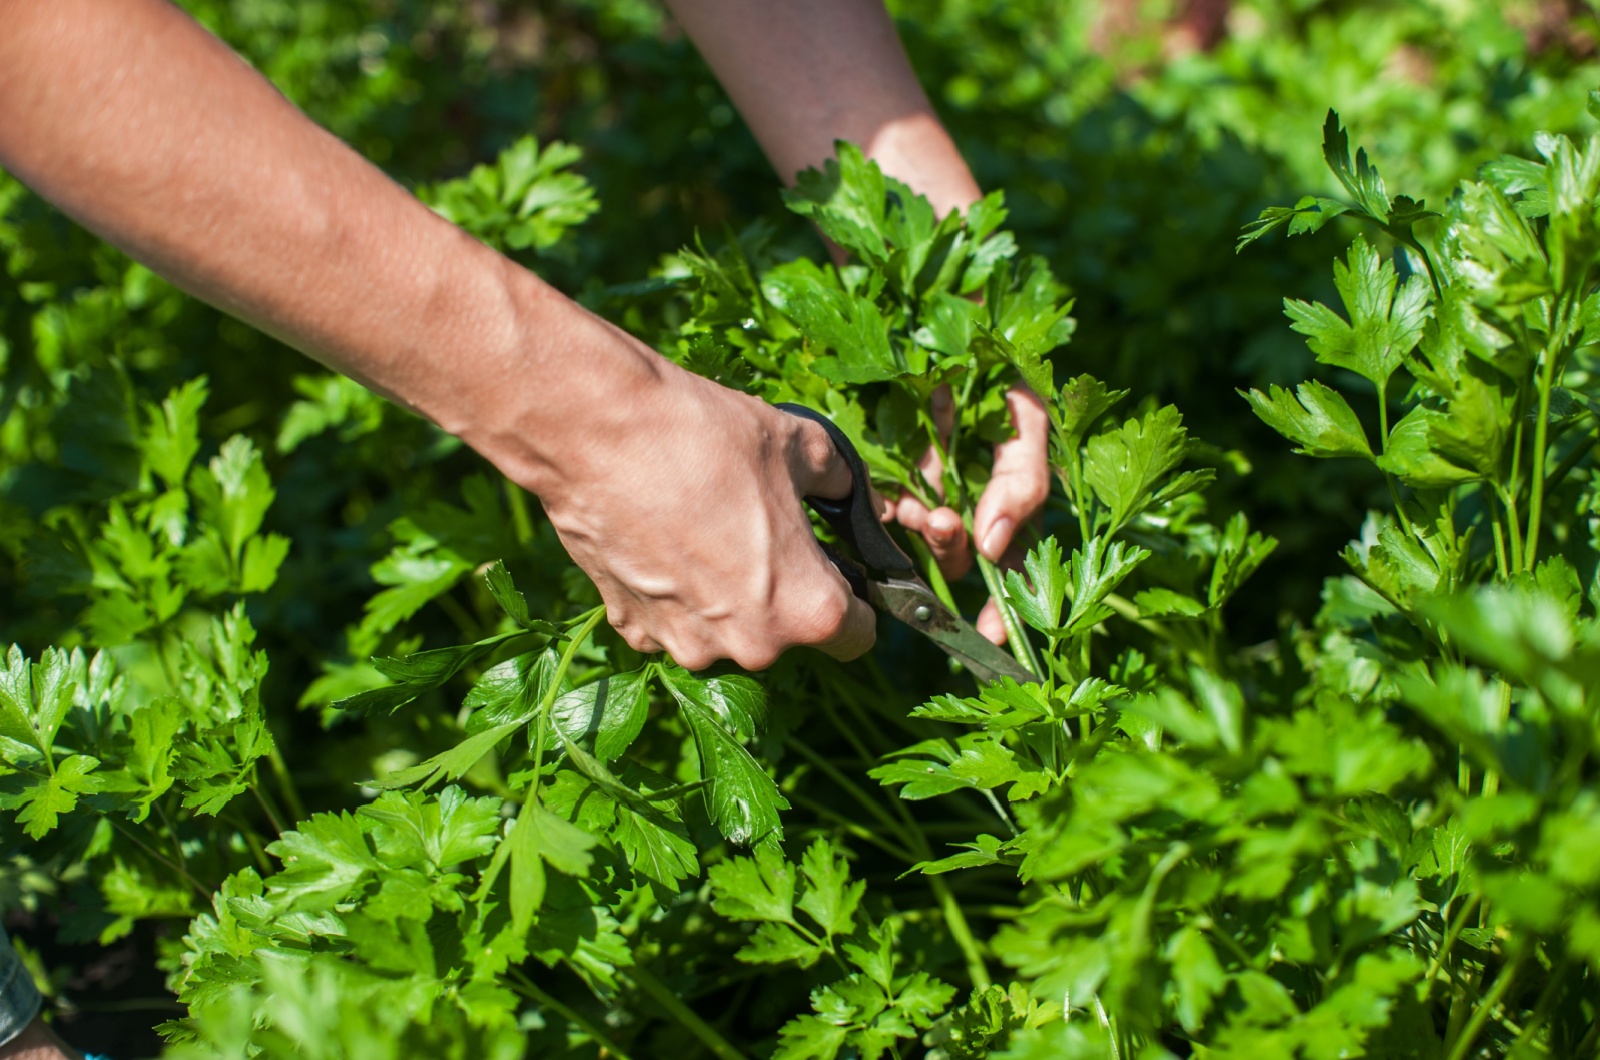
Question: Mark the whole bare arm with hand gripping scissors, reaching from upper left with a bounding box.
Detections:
[0,0,872,668]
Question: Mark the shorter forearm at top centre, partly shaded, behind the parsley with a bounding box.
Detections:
[667,0,981,211]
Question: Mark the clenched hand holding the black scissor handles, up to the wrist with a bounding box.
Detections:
[490,319,875,669]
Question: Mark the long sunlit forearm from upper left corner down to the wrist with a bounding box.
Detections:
[0,0,651,489]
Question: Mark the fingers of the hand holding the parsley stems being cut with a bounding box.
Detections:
[886,384,1050,644]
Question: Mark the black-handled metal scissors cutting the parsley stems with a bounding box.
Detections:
[778,402,1038,684]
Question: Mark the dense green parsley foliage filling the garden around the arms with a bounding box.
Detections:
[0,0,1600,1060]
